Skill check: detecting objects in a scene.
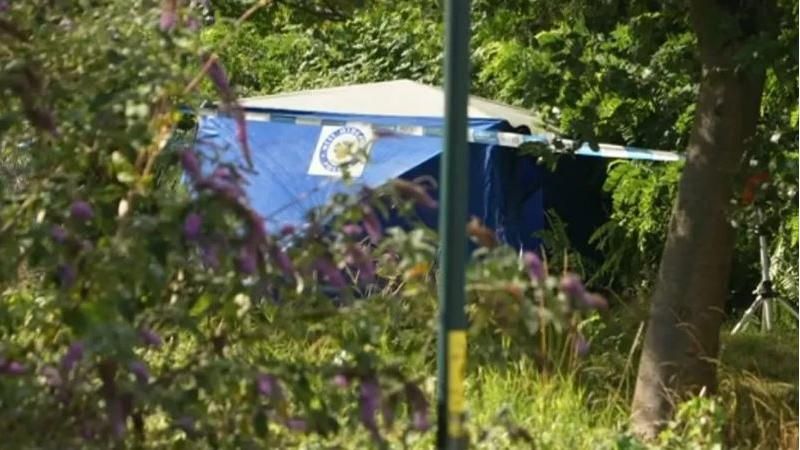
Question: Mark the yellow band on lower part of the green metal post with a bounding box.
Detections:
[447,330,467,437]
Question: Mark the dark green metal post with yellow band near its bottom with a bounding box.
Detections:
[437,0,470,449]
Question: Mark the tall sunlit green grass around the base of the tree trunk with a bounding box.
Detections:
[270,294,798,450]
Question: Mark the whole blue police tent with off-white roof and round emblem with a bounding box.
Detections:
[196,80,544,249]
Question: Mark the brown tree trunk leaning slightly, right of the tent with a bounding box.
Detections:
[632,0,769,438]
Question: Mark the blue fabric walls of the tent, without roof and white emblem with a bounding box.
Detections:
[196,109,544,249]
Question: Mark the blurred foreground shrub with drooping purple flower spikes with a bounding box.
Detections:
[0,0,604,448]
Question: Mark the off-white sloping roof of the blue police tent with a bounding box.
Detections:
[240,80,543,131]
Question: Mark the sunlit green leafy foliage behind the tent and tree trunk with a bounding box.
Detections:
[209,0,798,306]
